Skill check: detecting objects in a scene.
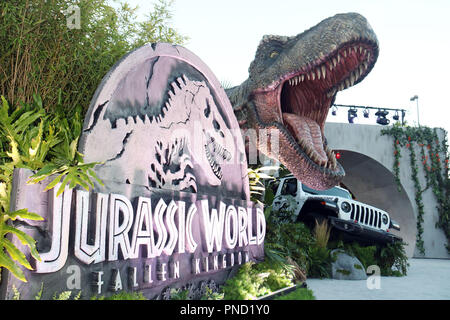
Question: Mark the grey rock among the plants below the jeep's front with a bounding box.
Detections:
[331,249,367,280]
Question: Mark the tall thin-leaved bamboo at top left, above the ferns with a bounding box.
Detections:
[0,0,187,114]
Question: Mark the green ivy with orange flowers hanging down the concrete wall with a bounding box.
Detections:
[381,125,450,254]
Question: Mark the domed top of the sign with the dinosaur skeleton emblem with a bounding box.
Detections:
[80,42,247,198]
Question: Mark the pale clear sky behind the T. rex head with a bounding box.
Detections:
[128,0,450,132]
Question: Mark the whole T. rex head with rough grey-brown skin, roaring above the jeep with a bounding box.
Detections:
[226,13,378,190]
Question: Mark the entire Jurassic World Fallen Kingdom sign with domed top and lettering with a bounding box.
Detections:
[2,44,266,299]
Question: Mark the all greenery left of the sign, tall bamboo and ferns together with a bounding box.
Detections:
[0,0,187,281]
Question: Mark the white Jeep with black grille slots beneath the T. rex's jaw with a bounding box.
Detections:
[271,175,402,243]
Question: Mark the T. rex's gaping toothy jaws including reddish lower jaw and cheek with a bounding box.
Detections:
[253,41,377,189]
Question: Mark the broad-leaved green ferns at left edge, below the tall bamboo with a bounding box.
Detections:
[0,95,102,281]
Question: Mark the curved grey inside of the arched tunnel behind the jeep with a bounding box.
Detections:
[334,149,417,257]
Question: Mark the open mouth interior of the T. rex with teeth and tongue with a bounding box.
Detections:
[277,42,376,170]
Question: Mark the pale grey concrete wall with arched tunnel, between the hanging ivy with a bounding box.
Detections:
[325,122,450,258]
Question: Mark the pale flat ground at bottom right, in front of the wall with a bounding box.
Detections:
[306,259,450,300]
